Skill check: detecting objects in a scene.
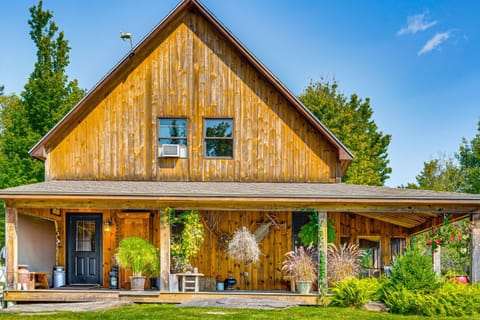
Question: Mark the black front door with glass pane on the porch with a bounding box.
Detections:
[67,213,102,284]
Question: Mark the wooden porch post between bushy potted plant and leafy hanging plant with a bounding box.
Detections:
[159,209,170,291]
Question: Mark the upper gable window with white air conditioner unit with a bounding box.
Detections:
[158,118,187,158]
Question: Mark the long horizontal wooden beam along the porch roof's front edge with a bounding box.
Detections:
[5,195,480,214]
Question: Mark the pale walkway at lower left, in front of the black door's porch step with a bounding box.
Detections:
[0,301,133,314]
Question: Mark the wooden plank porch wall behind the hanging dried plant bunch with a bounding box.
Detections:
[191,211,292,290]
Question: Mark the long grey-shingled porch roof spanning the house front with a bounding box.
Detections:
[0,180,480,228]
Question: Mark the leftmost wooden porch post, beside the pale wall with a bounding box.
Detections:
[5,207,18,287]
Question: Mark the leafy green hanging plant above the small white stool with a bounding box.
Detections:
[169,210,205,271]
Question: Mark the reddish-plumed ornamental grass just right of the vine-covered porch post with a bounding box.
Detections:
[327,243,362,286]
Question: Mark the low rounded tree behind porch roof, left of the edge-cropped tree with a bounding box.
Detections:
[406,156,463,192]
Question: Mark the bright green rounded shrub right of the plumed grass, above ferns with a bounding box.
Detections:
[385,247,440,292]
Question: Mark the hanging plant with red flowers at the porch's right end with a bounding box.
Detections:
[425,216,470,256]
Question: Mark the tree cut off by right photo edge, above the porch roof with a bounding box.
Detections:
[457,121,480,193]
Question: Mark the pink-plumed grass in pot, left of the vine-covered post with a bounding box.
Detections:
[282,244,317,294]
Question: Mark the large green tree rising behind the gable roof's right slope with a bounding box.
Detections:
[299,81,392,186]
